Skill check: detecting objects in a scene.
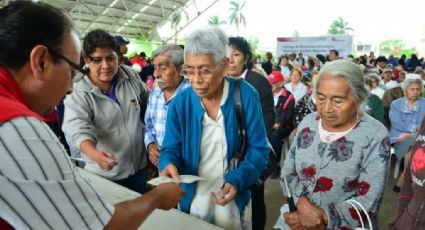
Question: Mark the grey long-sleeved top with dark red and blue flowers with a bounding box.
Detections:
[281,112,390,229]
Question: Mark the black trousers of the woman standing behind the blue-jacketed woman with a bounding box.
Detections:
[251,184,266,230]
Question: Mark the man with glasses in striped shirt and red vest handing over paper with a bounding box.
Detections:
[0,1,183,229]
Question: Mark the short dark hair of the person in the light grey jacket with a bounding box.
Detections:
[83,29,118,57]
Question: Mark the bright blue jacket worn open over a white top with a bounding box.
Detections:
[158,78,270,213]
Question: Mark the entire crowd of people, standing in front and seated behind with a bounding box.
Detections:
[0,1,425,229]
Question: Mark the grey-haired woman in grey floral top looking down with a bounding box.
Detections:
[281,60,390,229]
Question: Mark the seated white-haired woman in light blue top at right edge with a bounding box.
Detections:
[389,78,425,192]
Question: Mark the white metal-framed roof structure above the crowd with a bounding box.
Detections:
[0,0,218,42]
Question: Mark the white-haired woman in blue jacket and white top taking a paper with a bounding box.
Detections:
[159,27,270,229]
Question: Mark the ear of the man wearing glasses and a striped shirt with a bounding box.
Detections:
[29,45,52,80]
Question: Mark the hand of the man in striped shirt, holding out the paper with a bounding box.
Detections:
[151,183,184,210]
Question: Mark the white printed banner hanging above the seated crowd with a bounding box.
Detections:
[276,35,353,58]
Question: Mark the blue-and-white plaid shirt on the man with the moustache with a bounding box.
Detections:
[145,79,189,148]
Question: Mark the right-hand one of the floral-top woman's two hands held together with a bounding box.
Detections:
[297,196,328,229]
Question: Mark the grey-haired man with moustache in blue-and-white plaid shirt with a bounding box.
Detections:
[144,44,189,171]
